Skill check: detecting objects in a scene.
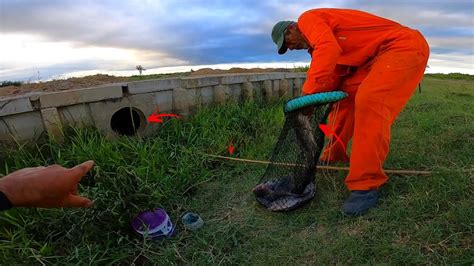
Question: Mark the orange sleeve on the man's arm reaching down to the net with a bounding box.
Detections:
[298,13,342,95]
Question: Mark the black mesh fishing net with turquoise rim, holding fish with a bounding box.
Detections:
[253,91,346,211]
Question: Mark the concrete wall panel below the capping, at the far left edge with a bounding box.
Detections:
[0,111,45,142]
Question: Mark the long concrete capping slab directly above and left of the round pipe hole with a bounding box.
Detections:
[40,84,123,108]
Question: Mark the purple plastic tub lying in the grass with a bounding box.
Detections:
[132,208,174,238]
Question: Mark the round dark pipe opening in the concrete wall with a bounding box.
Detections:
[110,107,146,136]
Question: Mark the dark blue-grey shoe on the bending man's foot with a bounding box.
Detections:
[342,189,380,216]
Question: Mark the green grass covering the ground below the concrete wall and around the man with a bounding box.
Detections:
[0,78,474,265]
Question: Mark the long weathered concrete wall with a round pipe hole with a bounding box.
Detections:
[0,72,306,143]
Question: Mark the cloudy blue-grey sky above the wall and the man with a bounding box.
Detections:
[0,0,474,81]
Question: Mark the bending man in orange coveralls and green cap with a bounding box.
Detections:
[272,8,429,215]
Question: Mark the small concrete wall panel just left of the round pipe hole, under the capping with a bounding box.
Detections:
[58,103,94,126]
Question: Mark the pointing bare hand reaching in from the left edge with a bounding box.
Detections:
[0,161,94,208]
